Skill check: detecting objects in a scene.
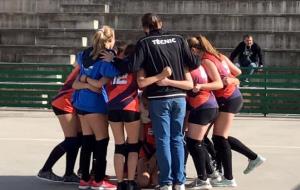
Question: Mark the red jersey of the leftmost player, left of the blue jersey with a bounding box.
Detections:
[51,65,80,113]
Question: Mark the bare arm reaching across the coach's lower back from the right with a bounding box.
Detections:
[157,69,194,90]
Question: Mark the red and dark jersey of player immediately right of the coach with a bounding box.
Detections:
[187,65,218,109]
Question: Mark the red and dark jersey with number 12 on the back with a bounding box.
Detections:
[107,74,139,112]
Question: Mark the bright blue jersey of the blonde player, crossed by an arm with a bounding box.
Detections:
[73,48,119,114]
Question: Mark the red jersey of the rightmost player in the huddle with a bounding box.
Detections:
[202,52,236,99]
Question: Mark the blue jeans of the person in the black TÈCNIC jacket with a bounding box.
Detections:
[149,97,186,186]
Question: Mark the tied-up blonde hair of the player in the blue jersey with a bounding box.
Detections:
[91,26,115,60]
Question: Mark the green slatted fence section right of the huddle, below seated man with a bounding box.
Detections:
[239,67,300,116]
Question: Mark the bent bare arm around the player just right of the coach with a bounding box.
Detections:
[193,59,223,92]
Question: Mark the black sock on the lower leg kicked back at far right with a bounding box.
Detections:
[228,136,257,160]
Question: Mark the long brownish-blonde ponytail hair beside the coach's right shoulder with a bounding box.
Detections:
[187,35,221,59]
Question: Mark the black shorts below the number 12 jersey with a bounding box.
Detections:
[108,110,140,123]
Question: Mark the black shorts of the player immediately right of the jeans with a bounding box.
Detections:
[188,108,218,125]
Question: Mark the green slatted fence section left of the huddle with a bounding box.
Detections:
[0,63,73,108]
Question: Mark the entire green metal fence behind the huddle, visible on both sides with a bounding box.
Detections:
[0,63,300,115]
